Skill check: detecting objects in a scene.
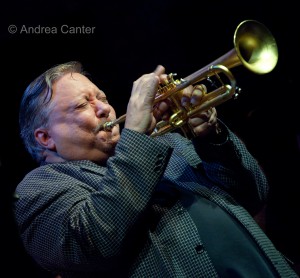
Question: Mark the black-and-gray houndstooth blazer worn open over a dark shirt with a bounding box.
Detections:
[15,124,298,278]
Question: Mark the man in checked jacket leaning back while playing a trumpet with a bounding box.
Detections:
[15,62,297,278]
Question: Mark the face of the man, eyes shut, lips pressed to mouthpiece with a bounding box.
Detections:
[39,73,120,164]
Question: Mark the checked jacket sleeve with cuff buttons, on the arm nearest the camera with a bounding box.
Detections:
[15,129,172,272]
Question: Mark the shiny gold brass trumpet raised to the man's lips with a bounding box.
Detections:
[102,20,278,137]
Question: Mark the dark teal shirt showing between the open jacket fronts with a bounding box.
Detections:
[184,191,276,278]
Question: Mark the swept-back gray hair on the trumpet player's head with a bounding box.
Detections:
[19,61,85,163]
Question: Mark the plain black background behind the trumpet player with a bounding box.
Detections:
[0,0,300,278]
